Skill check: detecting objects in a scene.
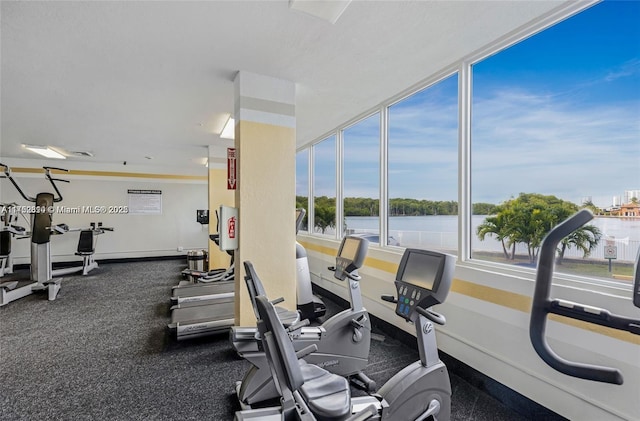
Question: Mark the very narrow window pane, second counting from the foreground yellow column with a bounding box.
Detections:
[313,136,336,236]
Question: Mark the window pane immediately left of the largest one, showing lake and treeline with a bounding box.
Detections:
[387,75,458,254]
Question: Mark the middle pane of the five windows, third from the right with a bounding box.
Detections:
[342,113,380,243]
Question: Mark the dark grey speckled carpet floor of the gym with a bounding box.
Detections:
[0,260,556,421]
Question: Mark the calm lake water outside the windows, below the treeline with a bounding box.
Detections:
[345,215,640,261]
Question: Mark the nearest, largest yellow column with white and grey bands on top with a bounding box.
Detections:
[234,71,296,326]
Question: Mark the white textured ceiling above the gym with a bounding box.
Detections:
[0,0,565,171]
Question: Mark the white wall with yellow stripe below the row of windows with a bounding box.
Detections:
[298,235,640,420]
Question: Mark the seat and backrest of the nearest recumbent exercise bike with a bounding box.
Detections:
[256,295,351,421]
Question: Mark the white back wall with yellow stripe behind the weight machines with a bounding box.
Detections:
[0,159,208,264]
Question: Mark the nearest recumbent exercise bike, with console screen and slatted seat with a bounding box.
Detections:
[235,244,455,421]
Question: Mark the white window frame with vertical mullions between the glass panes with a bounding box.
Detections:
[298,0,631,296]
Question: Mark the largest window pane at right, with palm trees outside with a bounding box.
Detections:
[471,2,640,279]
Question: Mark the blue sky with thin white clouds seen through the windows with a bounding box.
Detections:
[298,1,640,207]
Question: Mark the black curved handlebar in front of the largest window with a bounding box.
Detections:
[529,209,640,384]
